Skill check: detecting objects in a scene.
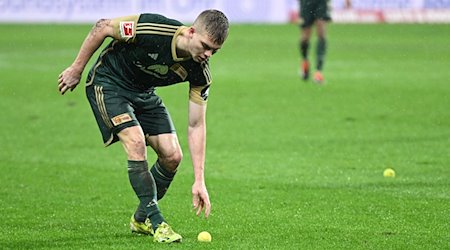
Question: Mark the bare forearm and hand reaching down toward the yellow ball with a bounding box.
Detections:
[188,101,211,217]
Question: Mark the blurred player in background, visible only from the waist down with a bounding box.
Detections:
[299,0,351,83]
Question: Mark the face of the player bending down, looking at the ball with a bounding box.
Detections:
[190,28,222,62]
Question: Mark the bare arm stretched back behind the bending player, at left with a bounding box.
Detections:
[58,19,114,95]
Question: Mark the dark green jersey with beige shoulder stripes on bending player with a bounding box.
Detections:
[87,14,211,103]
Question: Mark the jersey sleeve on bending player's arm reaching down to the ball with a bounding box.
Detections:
[189,62,212,105]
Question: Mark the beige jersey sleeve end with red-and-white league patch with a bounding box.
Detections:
[112,15,140,42]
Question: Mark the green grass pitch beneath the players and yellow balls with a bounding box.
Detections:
[0,24,450,249]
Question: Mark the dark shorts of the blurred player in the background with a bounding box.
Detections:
[300,0,331,28]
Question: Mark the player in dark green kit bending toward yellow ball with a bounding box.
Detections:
[58,10,229,243]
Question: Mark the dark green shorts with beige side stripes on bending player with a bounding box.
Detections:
[86,84,175,146]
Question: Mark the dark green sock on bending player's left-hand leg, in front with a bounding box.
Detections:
[128,161,164,229]
